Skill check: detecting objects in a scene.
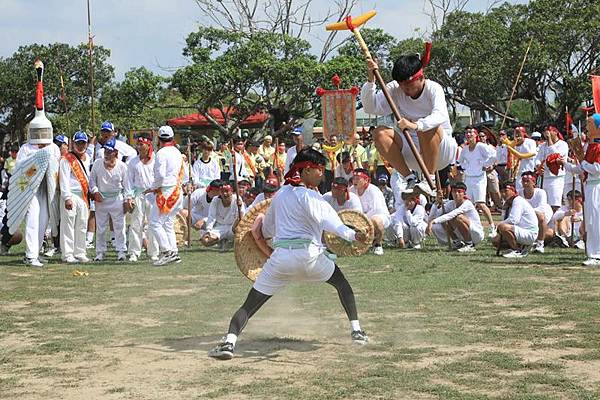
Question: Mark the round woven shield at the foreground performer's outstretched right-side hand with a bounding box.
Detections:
[324,210,374,257]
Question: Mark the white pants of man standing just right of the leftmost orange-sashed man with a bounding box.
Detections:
[96,196,127,255]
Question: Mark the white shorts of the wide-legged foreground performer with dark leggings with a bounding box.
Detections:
[253,244,335,296]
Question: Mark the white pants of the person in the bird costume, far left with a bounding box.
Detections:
[25,187,49,258]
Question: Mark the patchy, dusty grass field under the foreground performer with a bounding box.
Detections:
[0,239,600,399]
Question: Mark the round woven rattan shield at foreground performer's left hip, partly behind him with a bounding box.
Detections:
[233,199,271,282]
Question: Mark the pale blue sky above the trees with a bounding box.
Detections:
[0,0,527,79]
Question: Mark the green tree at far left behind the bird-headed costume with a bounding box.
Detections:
[0,43,114,141]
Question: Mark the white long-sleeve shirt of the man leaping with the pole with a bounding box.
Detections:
[360,79,452,134]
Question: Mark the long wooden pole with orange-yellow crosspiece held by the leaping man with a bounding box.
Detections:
[325,11,435,190]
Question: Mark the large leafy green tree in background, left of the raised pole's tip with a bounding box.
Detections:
[172,27,320,136]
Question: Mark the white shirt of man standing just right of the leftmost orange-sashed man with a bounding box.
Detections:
[90,159,131,198]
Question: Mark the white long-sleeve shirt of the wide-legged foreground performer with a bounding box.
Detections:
[262,185,355,246]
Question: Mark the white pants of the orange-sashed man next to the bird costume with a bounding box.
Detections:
[60,194,90,260]
